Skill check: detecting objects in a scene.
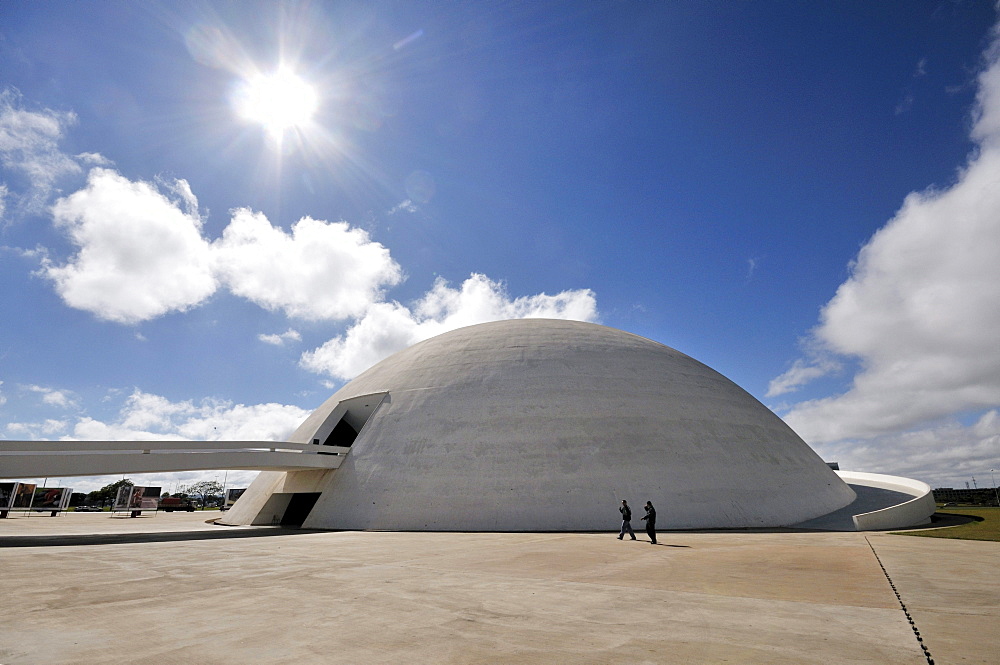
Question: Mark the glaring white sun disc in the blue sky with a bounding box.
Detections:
[234,68,319,140]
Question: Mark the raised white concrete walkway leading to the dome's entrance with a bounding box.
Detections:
[0,441,350,478]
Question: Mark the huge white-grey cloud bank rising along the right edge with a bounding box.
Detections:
[769,24,1000,478]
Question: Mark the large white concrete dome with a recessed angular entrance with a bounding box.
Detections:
[225,319,855,531]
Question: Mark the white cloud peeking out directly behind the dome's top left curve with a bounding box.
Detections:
[301,274,597,379]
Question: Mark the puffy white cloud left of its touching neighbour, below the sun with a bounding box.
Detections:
[42,168,216,323]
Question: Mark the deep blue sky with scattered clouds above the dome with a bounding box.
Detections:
[0,0,1000,490]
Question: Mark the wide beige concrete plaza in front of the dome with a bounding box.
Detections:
[0,513,1000,665]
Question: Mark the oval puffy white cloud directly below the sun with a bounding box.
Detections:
[213,209,403,320]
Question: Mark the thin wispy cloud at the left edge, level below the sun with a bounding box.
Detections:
[0,88,82,213]
